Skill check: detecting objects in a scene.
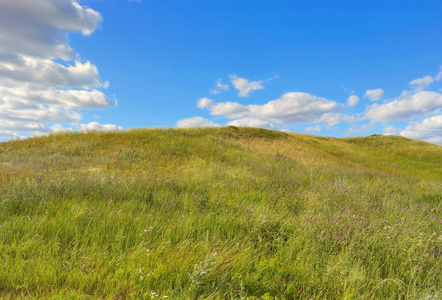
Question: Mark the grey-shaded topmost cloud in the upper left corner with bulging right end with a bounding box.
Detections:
[0,0,102,60]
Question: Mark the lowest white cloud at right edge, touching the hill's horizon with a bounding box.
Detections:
[400,115,442,145]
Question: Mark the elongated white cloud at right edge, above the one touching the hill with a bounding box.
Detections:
[365,91,442,123]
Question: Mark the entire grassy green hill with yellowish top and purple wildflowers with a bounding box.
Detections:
[0,127,442,299]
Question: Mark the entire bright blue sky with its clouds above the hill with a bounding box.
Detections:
[0,0,442,144]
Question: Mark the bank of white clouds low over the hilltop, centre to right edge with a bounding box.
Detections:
[177,71,442,144]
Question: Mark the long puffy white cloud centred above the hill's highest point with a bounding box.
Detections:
[210,92,340,124]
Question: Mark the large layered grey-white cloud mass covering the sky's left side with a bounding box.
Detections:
[0,0,116,138]
